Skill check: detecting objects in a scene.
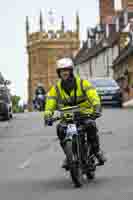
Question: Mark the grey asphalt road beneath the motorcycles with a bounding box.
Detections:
[0,108,133,200]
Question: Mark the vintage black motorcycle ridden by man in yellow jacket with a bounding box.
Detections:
[49,106,98,187]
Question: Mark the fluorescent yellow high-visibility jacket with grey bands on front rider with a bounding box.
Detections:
[45,76,100,114]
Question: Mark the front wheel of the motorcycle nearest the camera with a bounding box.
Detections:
[65,141,83,187]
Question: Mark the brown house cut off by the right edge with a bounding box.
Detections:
[112,22,133,101]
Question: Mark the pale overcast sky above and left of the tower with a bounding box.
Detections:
[0,0,120,101]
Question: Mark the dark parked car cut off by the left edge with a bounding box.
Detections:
[0,81,13,120]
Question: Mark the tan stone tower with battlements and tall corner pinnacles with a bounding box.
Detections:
[26,13,80,110]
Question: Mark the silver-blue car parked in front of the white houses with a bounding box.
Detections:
[90,78,123,107]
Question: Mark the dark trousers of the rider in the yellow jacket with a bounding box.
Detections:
[57,119,100,154]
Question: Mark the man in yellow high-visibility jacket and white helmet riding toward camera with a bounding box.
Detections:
[44,58,106,168]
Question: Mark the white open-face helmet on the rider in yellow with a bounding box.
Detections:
[56,58,74,72]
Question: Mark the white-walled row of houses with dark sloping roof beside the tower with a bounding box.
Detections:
[75,24,120,79]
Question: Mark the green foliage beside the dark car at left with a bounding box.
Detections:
[11,95,23,113]
